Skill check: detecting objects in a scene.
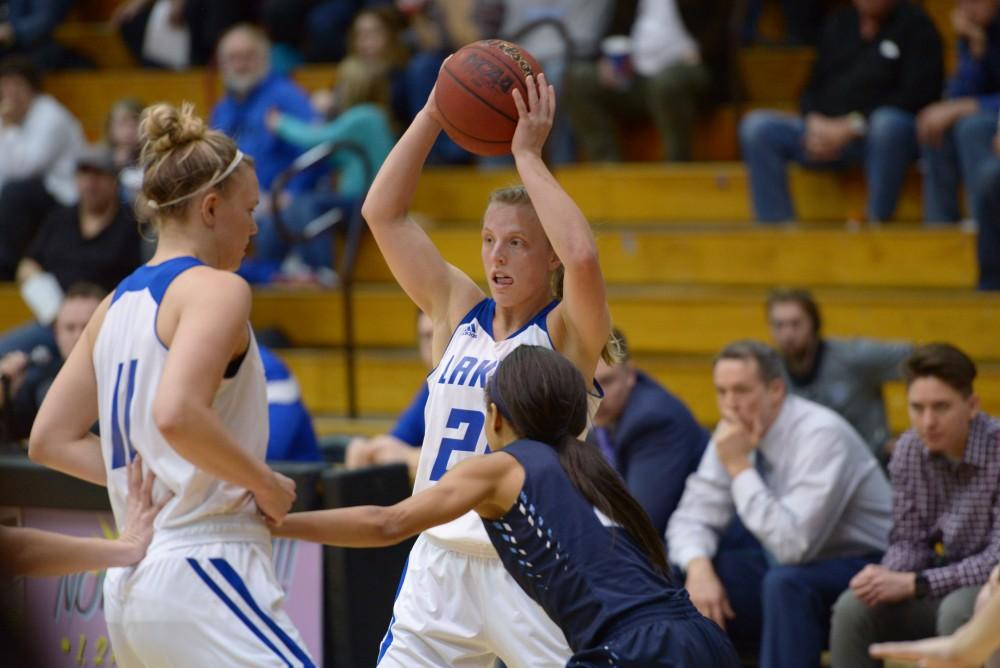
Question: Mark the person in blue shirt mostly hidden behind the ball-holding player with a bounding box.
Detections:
[344,311,434,480]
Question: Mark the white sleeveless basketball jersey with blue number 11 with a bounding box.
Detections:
[94,257,268,529]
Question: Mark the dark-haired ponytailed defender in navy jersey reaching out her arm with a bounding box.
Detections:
[274,345,739,668]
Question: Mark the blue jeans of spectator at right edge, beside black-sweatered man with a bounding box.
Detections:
[920,111,997,223]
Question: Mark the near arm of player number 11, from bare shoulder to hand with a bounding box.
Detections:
[153,267,295,521]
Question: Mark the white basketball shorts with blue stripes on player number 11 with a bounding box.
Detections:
[104,518,314,668]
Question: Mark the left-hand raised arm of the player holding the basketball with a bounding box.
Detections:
[361,91,483,329]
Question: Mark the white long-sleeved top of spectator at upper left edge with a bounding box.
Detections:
[0,94,84,206]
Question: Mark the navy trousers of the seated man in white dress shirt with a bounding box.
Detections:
[713,548,881,668]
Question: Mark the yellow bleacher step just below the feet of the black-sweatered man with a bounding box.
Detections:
[357,222,976,288]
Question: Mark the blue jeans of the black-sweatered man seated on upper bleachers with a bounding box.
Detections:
[739,107,918,223]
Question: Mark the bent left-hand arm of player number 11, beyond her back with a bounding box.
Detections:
[28,297,111,485]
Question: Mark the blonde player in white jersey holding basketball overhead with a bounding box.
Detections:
[362,56,611,668]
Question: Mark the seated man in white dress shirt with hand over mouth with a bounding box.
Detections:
[667,341,892,668]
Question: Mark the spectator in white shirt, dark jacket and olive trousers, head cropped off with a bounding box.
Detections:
[568,0,732,162]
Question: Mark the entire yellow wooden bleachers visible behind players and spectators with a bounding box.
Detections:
[13,0,984,444]
